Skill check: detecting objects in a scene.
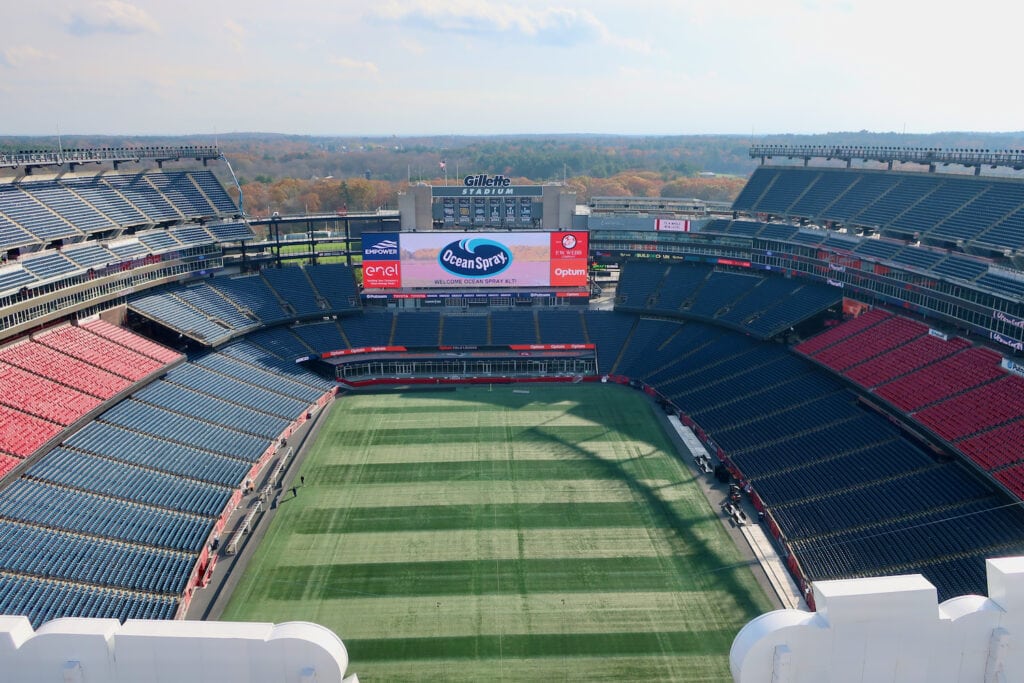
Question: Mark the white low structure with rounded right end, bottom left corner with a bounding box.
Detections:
[0,616,358,683]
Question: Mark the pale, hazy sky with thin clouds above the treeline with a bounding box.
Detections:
[0,0,1024,136]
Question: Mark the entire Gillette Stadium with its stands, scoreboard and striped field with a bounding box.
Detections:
[0,146,1024,681]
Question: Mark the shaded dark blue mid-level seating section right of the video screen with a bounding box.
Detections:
[616,261,842,339]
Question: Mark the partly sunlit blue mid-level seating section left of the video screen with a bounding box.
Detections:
[128,264,359,345]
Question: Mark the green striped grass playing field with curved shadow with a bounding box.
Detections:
[224,384,771,681]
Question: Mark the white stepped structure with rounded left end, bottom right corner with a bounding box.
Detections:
[729,557,1024,683]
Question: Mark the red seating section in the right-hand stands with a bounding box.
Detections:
[796,309,1024,498]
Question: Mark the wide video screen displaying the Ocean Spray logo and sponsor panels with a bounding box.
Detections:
[362,231,588,289]
